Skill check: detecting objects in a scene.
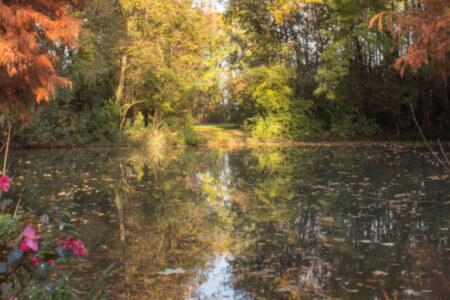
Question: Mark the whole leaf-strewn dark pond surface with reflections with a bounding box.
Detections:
[9,147,450,299]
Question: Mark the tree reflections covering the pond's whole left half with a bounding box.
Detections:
[10,150,232,299]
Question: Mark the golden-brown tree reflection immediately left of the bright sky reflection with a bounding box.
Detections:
[104,148,232,299]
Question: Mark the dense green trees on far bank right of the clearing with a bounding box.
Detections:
[225,0,450,138]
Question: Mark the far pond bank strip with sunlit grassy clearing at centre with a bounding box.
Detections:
[11,124,450,152]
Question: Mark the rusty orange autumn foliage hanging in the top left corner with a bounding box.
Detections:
[0,0,80,118]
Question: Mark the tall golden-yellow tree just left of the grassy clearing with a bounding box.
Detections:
[115,0,221,126]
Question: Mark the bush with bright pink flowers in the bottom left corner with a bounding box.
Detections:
[0,176,102,300]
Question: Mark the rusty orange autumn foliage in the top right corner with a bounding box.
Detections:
[370,0,450,81]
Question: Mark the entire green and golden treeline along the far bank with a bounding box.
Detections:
[0,0,450,144]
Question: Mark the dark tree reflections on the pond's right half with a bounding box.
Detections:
[221,149,448,298]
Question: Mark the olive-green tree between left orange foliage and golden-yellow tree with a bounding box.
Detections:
[64,0,126,111]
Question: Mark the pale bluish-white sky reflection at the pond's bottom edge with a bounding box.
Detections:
[198,255,236,299]
